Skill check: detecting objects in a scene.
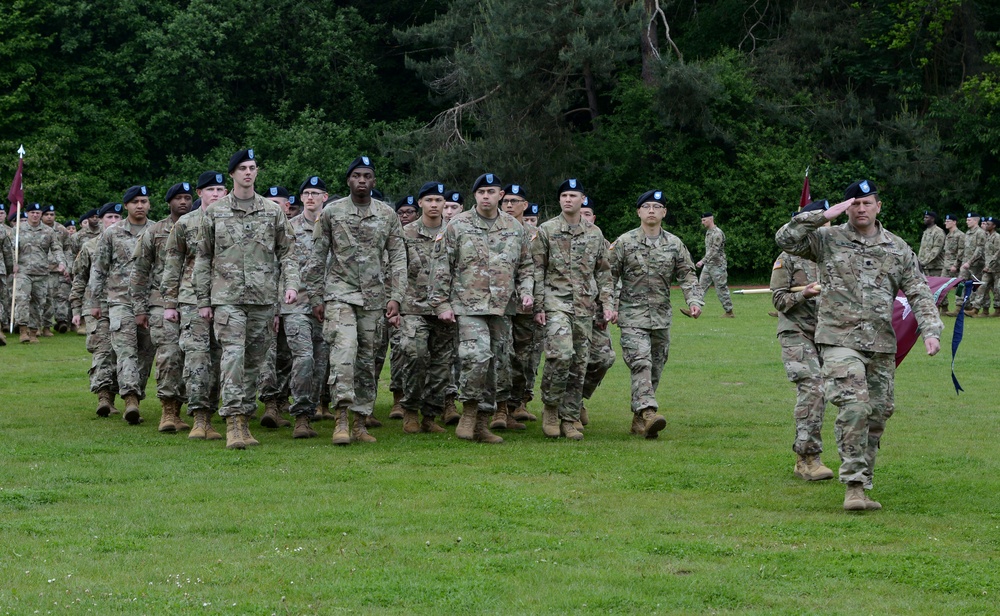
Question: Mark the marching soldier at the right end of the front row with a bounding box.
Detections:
[609,190,705,439]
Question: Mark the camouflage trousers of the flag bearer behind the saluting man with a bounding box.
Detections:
[778,332,826,456]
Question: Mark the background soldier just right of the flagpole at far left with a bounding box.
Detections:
[14,203,68,343]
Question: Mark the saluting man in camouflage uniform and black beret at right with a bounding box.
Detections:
[775,180,943,511]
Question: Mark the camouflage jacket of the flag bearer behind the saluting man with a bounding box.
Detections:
[771,252,819,339]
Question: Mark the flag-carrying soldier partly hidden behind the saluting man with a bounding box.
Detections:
[771,200,833,481]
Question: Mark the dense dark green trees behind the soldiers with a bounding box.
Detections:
[0,0,1000,275]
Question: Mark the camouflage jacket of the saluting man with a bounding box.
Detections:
[775,212,944,353]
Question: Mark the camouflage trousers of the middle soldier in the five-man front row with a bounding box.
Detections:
[457,314,508,411]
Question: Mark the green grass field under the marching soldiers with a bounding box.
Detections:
[0,291,1000,614]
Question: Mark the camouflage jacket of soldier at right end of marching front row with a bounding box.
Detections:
[609,227,705,329]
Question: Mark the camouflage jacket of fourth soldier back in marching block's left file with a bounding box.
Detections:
[85,218,153,310]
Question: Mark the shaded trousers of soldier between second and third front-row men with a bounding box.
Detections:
[399,314,455,416]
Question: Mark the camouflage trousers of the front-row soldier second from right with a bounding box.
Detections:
[542,311,594,421]
